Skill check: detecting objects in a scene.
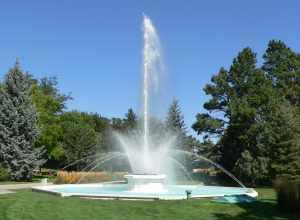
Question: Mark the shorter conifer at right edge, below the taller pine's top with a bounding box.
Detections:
[267,102,300,178]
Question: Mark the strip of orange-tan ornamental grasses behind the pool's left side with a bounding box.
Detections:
[54,171,126,184]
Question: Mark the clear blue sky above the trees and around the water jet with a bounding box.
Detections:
[0,0,300,133]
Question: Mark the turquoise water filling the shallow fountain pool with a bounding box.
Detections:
[45,184,251,199]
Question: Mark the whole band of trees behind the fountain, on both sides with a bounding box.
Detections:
[0,40,300,185]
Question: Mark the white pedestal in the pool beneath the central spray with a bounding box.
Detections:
[124,174,166,193]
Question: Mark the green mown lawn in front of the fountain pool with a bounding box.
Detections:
[0,189,300,220]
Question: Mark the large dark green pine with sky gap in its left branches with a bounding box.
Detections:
[192,48,274,182]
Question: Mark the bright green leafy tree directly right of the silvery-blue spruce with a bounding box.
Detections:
[30,77,72,162]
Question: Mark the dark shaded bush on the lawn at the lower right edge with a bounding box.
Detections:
[274,175,300,212]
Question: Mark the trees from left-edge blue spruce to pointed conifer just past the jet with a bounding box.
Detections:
[0,61,197,180]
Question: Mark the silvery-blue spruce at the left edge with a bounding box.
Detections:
[0,61,44,180]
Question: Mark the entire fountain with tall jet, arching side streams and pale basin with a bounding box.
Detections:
[33,15,257,199]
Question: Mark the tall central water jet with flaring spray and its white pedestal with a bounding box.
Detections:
[112,15,175,192]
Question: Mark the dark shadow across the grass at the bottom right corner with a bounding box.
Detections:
[214,199,300,220]
